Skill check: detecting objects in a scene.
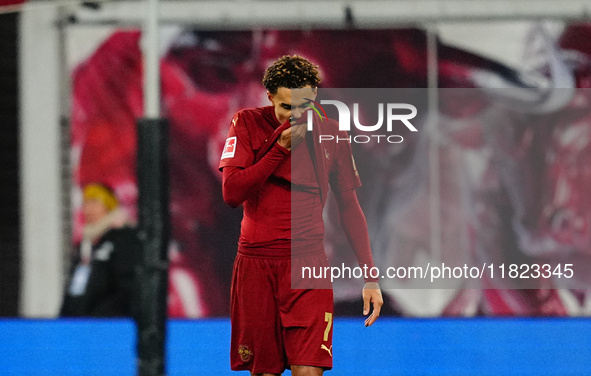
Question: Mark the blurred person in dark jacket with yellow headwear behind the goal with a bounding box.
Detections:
[60,183,140,317]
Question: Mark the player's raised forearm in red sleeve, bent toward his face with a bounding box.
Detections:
[222,145,289,208]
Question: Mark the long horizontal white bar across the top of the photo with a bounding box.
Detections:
[74,0,591,29]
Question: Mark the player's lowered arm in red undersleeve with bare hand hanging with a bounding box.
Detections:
[333,189,384,326]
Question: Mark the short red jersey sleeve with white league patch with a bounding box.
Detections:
[219,112,254,170]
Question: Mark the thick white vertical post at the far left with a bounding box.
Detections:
[19,7,64,317]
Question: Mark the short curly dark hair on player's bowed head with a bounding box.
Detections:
[262,55,322,94]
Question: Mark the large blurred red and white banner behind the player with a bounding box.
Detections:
[72,25,591,317]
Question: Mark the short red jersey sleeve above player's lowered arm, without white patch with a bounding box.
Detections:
[330,131,361,192]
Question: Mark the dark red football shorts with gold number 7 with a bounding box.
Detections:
[230,252,333,373]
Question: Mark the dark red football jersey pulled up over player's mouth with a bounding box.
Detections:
[219,106,361,257]
